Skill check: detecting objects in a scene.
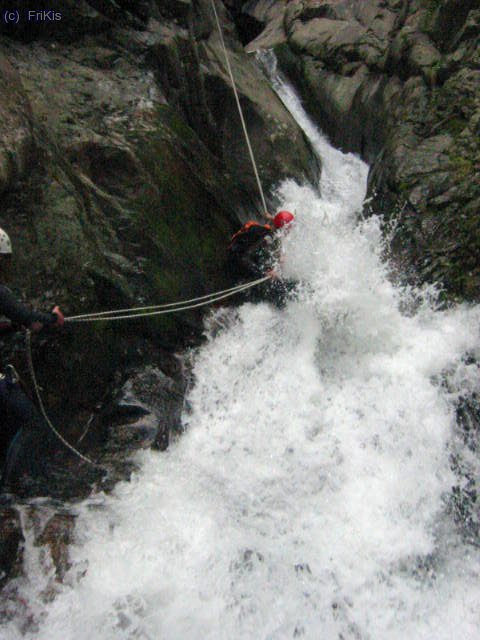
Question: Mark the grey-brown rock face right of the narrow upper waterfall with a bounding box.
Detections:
[248,0,480,300]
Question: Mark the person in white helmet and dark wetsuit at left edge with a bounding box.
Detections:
[0,229,63,489]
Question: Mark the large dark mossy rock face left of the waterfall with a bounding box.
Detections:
[0,0,319,458]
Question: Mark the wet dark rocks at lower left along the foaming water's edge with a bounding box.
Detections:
[0,357,184,592]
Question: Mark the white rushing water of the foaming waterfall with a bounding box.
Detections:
[2,56,480,640]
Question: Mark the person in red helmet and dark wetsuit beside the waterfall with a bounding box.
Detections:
[227,211,296,308]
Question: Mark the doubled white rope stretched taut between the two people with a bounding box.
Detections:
[65,276,271,323]
